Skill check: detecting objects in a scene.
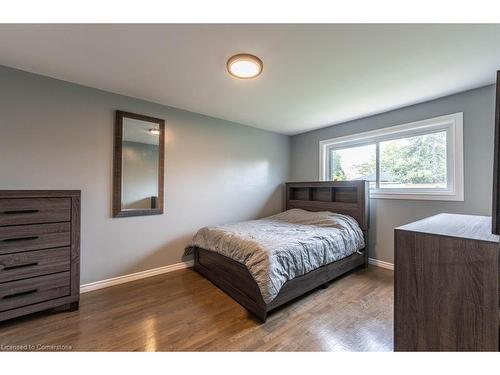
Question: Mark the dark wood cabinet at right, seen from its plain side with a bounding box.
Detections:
[394,214,500,351]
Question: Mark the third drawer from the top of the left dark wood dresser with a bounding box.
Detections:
[0,247,71,283]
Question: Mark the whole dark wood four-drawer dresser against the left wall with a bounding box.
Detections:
[0,190,80,321]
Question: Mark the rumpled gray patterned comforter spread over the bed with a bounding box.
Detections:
[186,209,365,303]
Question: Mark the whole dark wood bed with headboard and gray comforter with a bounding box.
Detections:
[188,181,369,322]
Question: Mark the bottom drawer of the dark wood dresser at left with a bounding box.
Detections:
[0,272,70,311]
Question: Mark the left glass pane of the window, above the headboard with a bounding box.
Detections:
[329,144,376,181]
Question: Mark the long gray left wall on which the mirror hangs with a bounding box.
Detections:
[0,67,290,283]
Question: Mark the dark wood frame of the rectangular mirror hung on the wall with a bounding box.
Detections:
[113,111,165,217]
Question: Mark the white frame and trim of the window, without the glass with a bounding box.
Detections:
[319,112,464,201]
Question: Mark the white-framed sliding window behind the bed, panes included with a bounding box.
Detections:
[320,113,464,201]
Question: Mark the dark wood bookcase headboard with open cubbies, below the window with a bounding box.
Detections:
[285,180,369,231]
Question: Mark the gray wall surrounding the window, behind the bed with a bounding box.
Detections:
[291,86,495,263]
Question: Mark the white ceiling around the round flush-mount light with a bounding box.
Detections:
[0,24,500,134]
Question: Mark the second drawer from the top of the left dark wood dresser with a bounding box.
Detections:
[0,223,71,255]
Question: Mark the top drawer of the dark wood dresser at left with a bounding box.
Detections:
[0,198,71,226]
